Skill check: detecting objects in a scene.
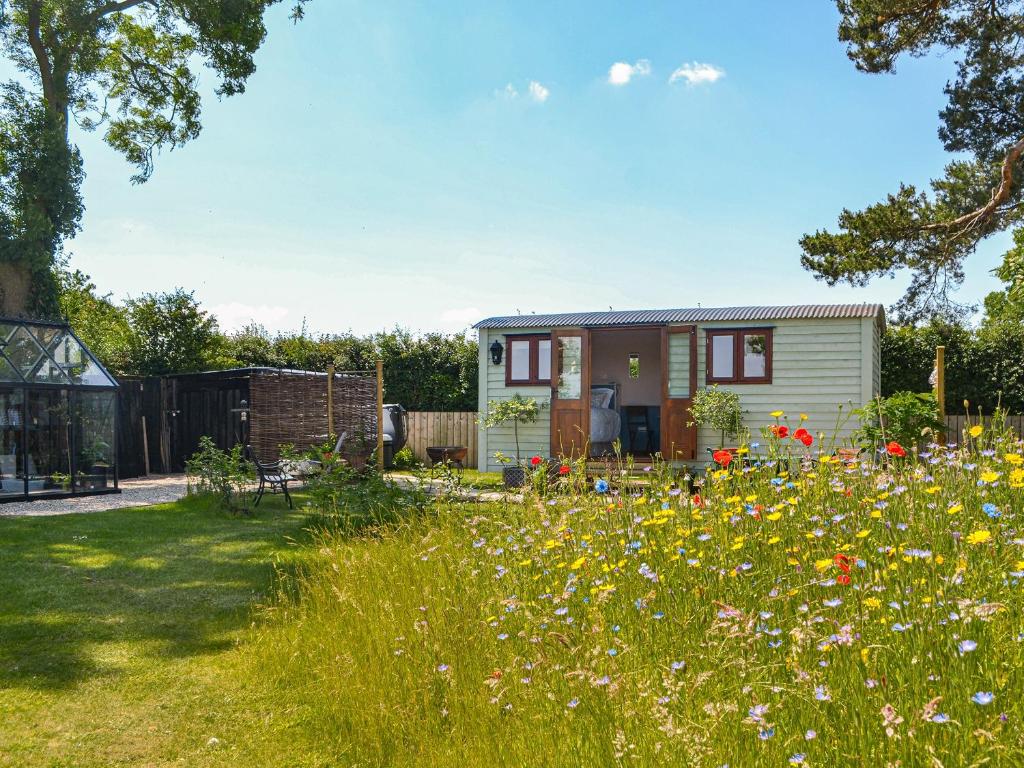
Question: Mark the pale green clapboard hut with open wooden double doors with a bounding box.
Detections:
[475,304,885,470]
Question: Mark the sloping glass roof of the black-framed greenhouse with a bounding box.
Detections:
[0,317,118,388]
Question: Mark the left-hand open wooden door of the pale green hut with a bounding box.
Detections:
[551,328,590,458]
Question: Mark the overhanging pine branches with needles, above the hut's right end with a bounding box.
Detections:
[800,0,1024,321]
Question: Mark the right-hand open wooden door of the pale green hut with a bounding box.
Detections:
[662,326,697,461]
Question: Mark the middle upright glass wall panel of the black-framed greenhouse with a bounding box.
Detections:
[26,389,71,495]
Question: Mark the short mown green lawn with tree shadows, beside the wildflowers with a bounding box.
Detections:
[0,499,315,768]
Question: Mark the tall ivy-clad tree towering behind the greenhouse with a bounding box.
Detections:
[0,0,307,314]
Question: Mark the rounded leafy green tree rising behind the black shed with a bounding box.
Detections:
[124,288,225,376]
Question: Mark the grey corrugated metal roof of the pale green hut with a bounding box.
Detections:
[473,304,885,329]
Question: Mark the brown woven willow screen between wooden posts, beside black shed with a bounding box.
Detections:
[249,371,377,461]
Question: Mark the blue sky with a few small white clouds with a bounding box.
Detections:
[24,0,1009,333]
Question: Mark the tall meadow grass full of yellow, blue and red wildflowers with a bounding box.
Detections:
[247,417,1024,768]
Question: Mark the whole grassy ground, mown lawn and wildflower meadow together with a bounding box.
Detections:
[6,423,1024,768]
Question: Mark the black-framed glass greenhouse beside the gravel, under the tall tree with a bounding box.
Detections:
[0,318,118,503]
